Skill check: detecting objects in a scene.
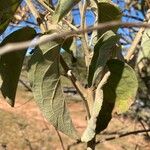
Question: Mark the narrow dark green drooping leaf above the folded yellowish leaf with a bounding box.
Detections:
[88,30,119,87]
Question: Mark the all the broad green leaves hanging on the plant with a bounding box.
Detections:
[0,0,138,145]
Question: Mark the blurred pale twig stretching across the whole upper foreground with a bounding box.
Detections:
[0,21,150,55]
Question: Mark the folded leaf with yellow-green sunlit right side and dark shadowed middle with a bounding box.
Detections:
[81,59,138,142]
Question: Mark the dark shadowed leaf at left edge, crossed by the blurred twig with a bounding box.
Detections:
[0,27,36,106]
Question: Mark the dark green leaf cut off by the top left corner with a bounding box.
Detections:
[0,0,22,34]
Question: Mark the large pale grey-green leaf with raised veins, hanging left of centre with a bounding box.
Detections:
[29,38,78,139]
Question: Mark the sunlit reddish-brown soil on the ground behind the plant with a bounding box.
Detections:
[0,90,150,150]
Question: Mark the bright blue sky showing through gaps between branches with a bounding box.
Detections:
[0,0,143,47]
